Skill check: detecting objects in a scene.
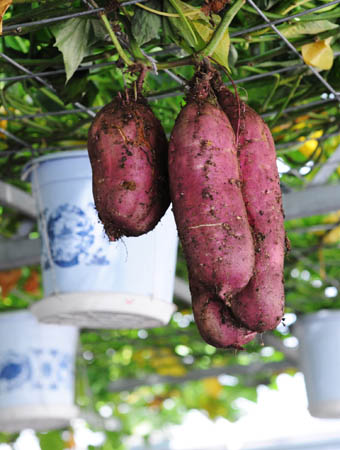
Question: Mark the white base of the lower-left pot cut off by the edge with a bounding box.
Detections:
[0,405,79,433]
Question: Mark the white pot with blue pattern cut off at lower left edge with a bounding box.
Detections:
[0,311,78,432]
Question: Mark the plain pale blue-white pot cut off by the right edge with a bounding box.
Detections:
[294,310,340,418]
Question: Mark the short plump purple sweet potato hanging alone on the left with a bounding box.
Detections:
[88,92,170,240]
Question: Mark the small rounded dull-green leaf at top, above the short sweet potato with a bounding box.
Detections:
[131,0,162,45]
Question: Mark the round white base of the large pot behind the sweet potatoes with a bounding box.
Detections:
[30,291,176,330]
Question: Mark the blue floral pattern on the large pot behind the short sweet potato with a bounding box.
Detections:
[43,203,109,269]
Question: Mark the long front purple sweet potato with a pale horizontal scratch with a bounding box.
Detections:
[169,77,255,302]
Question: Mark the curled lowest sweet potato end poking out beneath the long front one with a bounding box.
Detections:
[190,284,257,350]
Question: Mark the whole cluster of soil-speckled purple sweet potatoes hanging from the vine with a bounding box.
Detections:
[88,69,285,348]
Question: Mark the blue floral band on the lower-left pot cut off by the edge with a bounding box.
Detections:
[0,348,73,394]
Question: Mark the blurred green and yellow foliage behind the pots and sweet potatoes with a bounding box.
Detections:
[0,0,340,450]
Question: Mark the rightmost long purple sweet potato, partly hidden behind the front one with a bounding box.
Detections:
[213,78,285,332]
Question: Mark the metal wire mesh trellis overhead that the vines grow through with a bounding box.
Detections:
[0,0,340,173]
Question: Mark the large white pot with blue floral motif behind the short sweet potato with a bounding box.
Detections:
[24,151,178,329]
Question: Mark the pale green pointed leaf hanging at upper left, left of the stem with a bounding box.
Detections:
[51,18,90,82]
